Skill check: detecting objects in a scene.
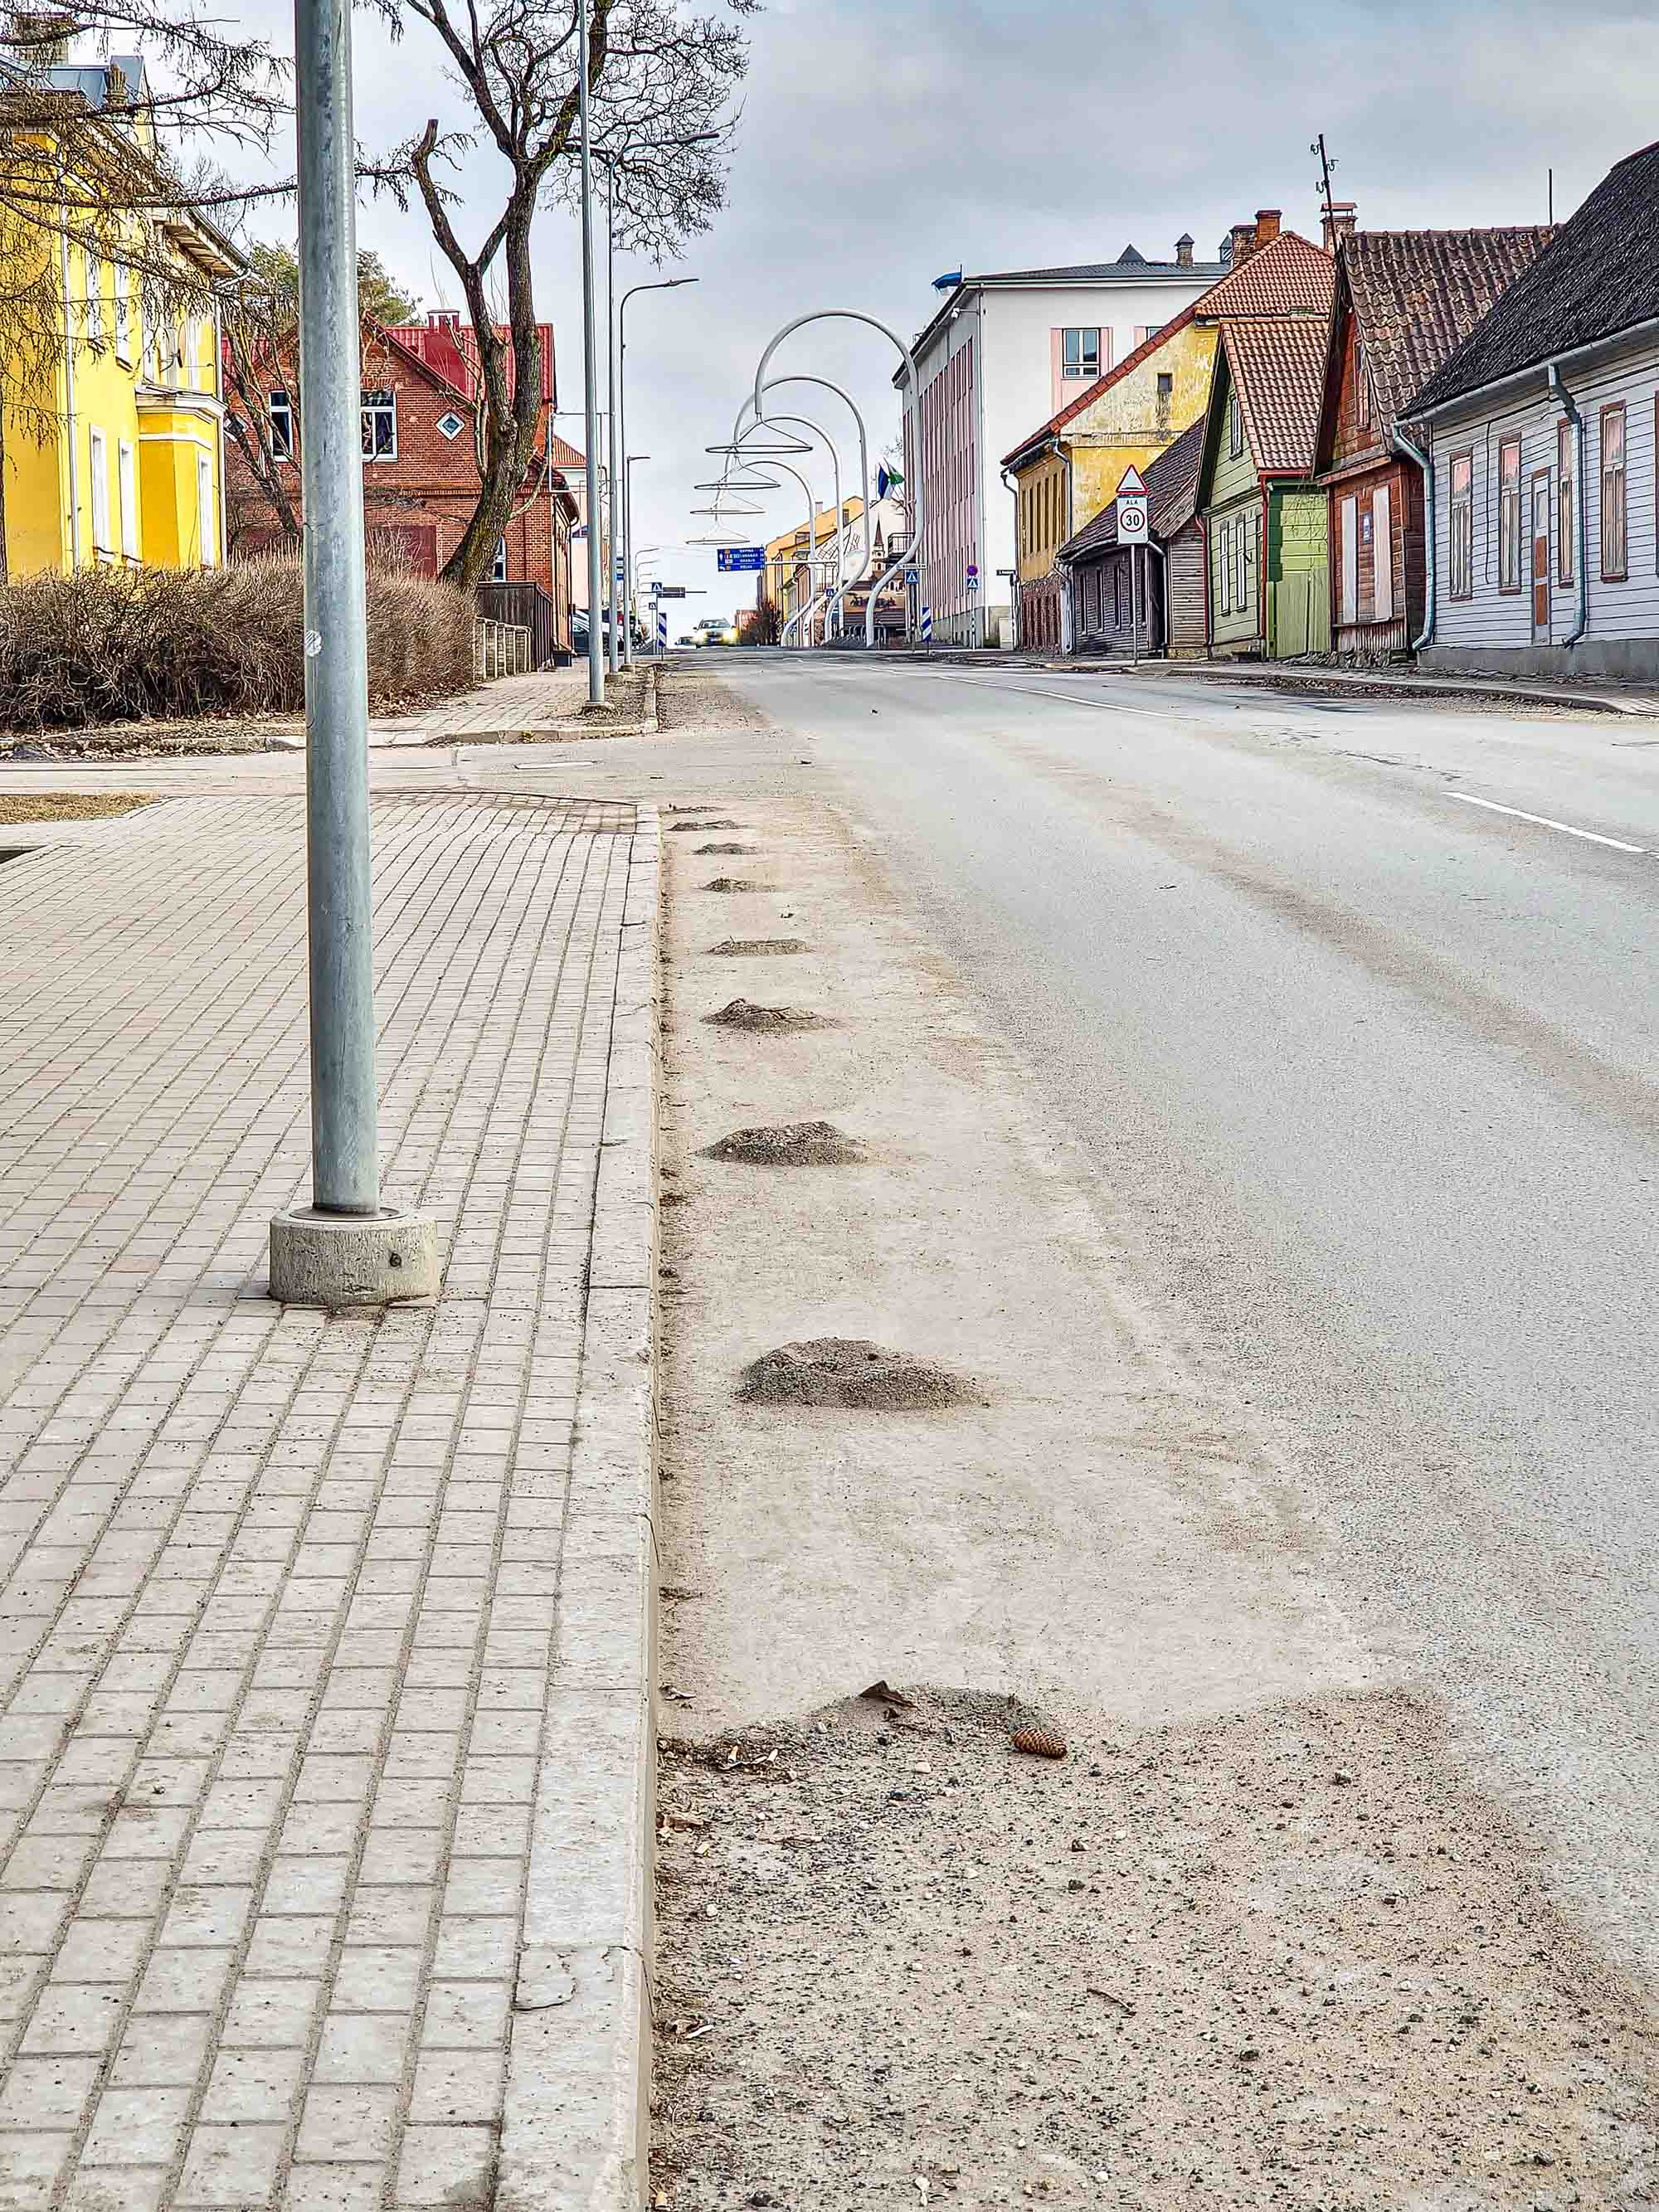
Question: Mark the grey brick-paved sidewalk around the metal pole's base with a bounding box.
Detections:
[0,790,654,2212]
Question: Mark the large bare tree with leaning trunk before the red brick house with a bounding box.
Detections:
[378,0,757,591]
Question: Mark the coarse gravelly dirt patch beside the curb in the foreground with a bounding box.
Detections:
[653,1680,1659,2212]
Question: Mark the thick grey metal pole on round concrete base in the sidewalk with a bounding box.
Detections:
[270,0,438,1305]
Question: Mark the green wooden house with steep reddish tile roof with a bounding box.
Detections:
[1199,314,1331,661]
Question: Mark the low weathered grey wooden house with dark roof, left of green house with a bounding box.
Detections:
[1059,421,1205,657]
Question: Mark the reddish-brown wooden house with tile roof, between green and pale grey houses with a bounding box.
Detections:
[1316,220,1550,659]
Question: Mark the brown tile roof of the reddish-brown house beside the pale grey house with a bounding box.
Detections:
[1340,223,1555,422]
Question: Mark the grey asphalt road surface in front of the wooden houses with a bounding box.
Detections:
[708,657,1659,1976]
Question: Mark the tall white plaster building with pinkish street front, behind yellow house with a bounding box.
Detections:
[893,236,1232,646]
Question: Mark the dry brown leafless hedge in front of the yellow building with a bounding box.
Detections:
[0,557,474,730]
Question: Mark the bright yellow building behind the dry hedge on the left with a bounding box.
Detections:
[0,57,246,577]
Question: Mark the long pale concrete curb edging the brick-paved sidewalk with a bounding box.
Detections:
[494,807,661,2212]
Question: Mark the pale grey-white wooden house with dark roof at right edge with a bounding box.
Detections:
[1404,143,1659,681]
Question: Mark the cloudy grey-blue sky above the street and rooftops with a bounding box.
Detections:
[231,0,1659,620]
